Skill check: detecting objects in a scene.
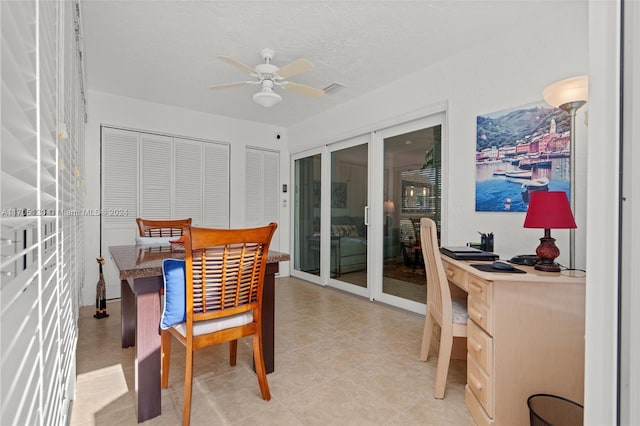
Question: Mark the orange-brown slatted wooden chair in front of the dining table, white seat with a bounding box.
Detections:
[162,223,277,425]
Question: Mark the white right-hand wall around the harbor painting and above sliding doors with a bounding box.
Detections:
[289,3,588,268]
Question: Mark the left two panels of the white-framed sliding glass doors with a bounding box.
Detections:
[292,135,370,297]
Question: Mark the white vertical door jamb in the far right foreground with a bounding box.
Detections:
[584,0,620,426]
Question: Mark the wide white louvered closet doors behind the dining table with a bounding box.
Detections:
[104,126,230,299]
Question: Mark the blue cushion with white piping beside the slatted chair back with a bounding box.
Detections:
[160,259,187,330]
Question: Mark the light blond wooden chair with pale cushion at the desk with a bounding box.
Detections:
[420,217,469,399]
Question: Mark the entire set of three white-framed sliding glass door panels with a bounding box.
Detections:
[292,113,445,313]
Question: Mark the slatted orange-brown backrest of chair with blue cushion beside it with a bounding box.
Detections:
[184,223,277,322]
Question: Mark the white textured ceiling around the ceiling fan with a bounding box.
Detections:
[80,0,571,127]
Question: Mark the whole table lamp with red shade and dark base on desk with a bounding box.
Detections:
[523,191,576,272]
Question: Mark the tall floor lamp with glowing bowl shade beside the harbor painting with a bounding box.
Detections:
[542,75,589,269]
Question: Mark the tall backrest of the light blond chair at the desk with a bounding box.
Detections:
[420,217,453,327]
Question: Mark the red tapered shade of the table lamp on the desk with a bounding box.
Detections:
[523,191,577,229]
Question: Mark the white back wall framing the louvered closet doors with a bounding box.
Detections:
[81,91,290,305]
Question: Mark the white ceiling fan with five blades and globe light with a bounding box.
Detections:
[209,49,325,108]
